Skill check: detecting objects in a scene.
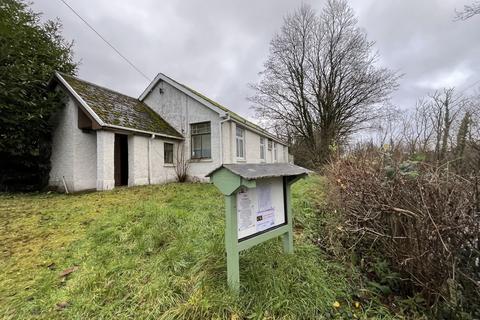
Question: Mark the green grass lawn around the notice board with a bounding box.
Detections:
[0,177,391,319]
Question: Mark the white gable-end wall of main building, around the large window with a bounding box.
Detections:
[144,81,222,181]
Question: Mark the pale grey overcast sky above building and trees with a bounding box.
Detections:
[33,0,480,122]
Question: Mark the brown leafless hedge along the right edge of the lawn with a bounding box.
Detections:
[324,148,480,310]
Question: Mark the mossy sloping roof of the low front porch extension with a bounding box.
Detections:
[55,72,183,139]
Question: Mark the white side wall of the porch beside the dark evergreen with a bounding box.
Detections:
[49,96,97,192]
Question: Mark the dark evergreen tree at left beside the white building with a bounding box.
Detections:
[0,0,76,191]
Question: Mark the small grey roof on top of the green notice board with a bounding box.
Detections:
[207,163,311,180]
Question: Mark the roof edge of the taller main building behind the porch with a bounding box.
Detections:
[138,73,285,144]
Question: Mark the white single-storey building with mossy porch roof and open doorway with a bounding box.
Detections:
[49,73,289,192]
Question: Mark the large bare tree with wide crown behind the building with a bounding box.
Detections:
[250,0,398,166]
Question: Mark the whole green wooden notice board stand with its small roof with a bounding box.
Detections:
[207,163,309,292]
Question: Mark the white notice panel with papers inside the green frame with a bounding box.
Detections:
[237,177,287,241]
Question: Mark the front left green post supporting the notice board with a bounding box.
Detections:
[225,193,240,293]
